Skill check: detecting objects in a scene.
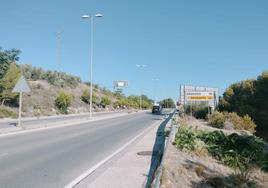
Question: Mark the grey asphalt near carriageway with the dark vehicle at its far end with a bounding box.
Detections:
[0,112,172,188]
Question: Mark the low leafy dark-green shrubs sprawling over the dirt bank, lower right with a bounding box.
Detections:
[175,125,268,187]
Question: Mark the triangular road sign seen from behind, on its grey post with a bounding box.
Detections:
[12,76,31,127]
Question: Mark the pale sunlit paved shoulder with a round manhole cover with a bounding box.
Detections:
[76,118,160,188]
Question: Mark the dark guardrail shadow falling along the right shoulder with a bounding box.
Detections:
[145,113,173,188]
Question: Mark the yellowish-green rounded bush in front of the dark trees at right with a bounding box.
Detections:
[208,111,256,133]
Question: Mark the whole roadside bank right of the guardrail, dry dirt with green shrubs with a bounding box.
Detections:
[161,115,268,188]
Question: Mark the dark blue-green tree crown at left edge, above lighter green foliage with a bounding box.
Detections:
[0,47,20,79]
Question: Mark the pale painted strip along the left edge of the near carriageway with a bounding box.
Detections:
[0,113,135,138]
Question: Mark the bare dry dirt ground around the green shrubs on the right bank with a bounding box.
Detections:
[161,118,268,188]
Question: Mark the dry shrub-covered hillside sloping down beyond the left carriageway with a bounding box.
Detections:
[0,48,153,118]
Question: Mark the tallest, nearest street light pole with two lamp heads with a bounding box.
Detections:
[81,14,102,118]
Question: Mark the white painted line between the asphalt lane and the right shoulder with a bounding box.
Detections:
[64,120,163,188]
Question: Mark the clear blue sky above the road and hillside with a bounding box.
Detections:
[0,0,268,100]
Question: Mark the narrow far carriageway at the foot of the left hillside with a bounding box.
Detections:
[0,111,127,128]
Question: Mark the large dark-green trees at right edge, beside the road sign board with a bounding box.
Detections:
[218,71,268,139]
